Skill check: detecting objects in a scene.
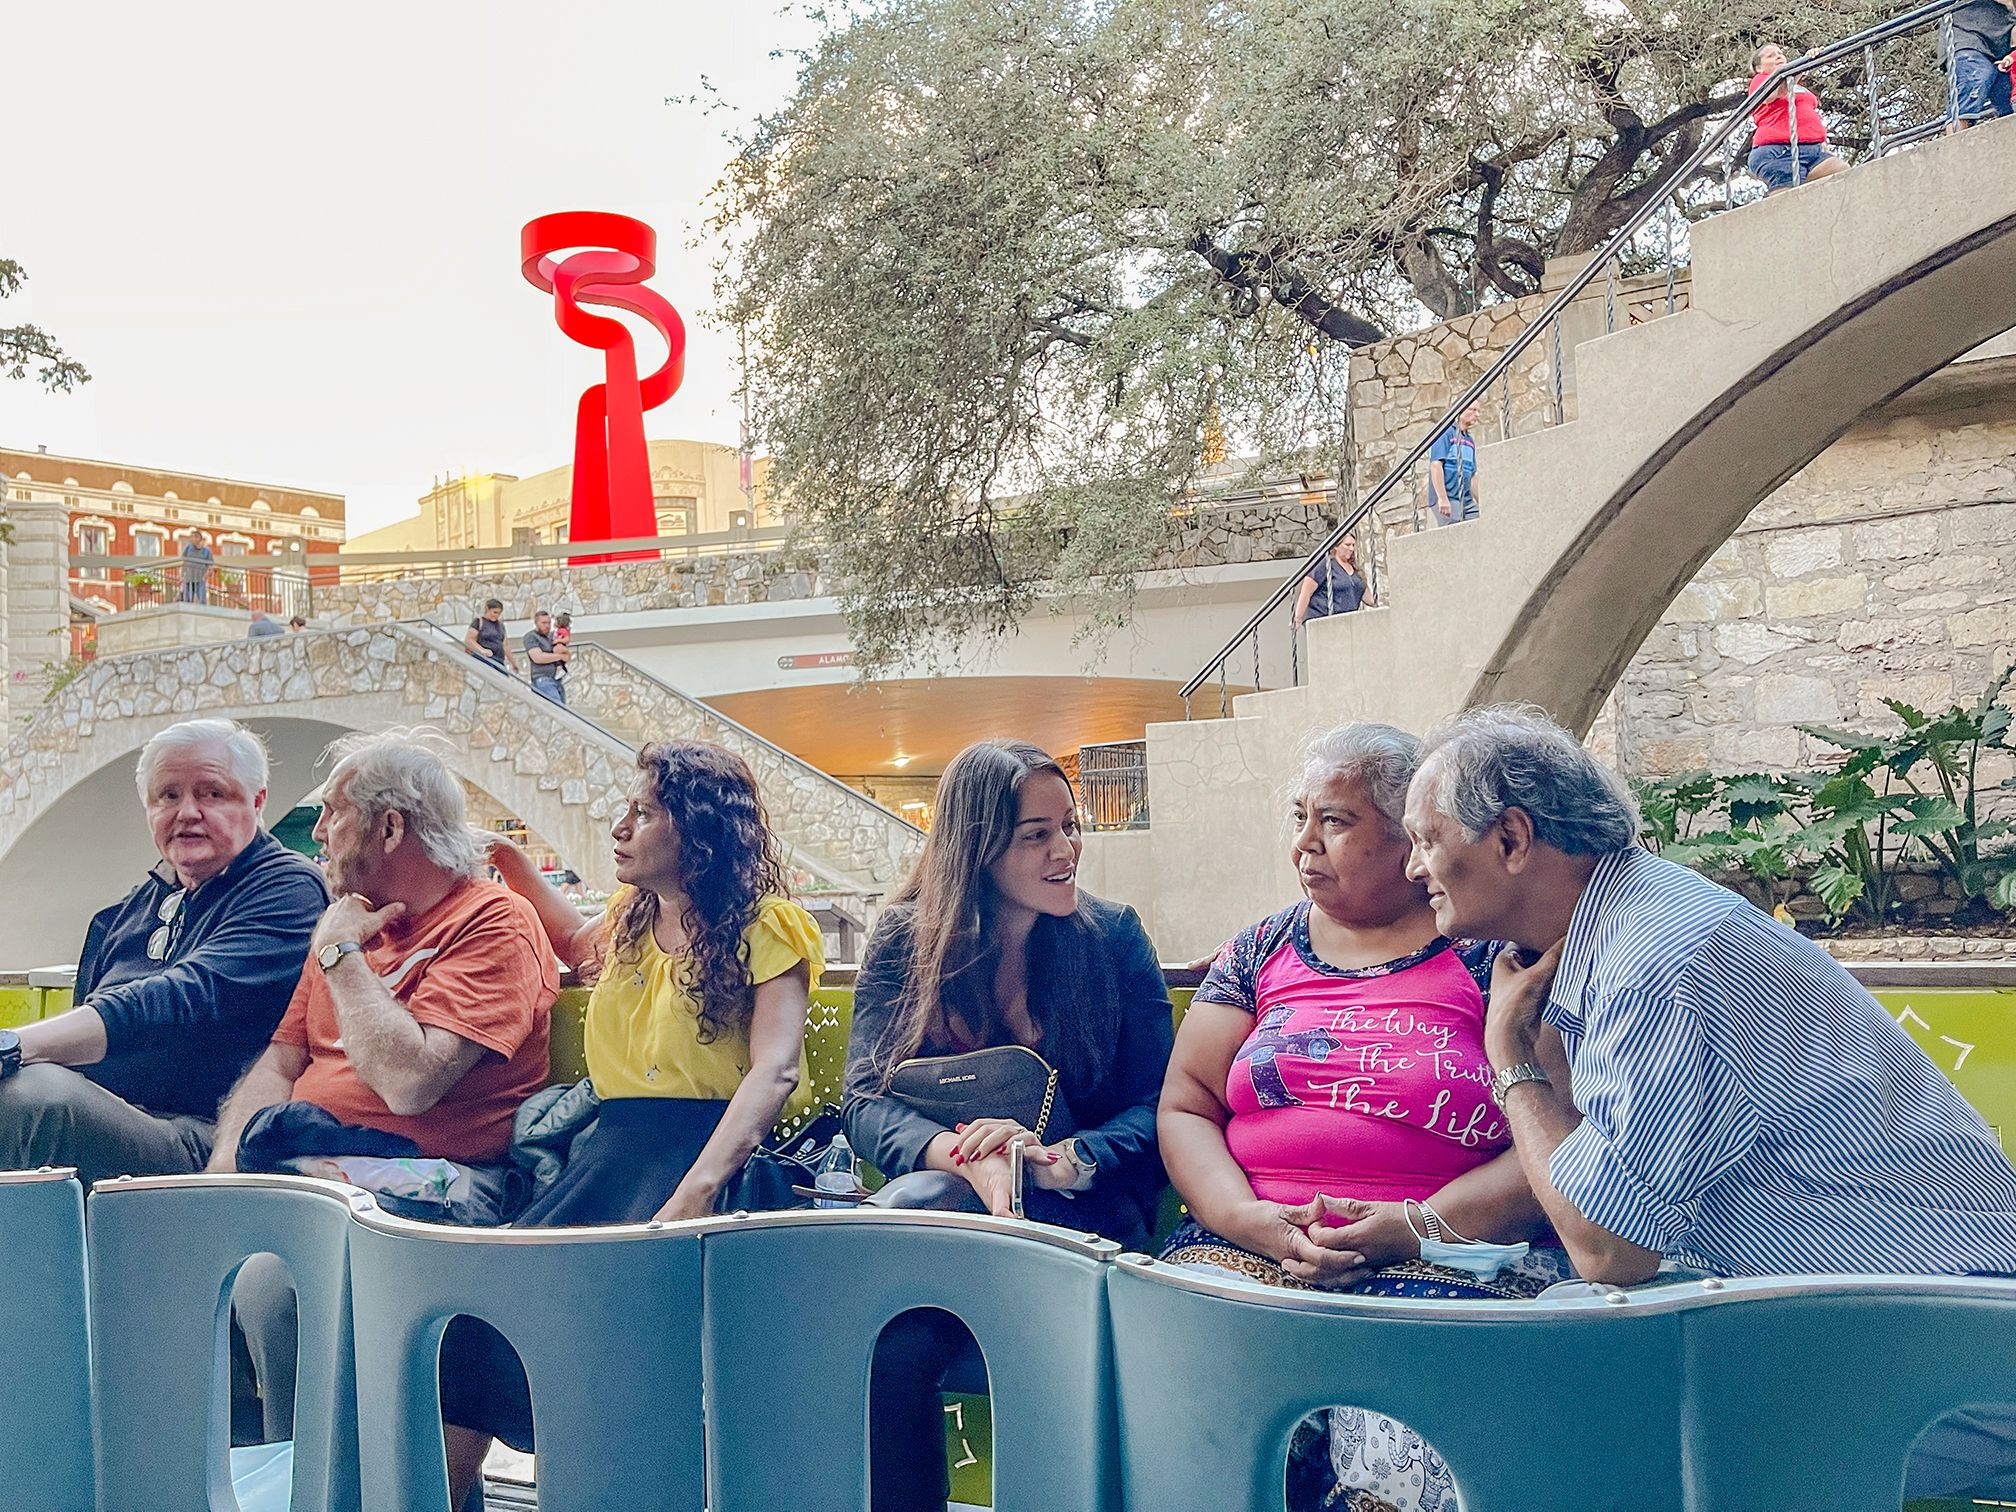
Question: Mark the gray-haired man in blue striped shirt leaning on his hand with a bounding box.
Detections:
[1407,708,2016,1284]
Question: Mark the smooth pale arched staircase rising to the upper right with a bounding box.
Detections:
[1131,123,2016,958]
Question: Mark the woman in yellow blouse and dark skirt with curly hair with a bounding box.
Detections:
[442,740,825,1508]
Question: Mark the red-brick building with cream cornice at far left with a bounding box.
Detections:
[0,448,343,613]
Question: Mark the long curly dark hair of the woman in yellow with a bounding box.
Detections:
[611,740,784,1044]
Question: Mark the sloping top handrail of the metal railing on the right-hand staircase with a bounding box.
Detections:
[1177,0,1968,718]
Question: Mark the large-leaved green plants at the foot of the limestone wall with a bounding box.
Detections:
[1637,667,2016,925]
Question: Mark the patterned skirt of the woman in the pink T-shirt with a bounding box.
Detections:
[1161,1220,1574,1512]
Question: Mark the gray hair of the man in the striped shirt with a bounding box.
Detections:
[1427,704,1639,855]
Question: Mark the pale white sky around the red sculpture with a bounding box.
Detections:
[0,0,812,534]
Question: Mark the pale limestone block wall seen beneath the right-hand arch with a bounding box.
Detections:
[1597,385,2016,780]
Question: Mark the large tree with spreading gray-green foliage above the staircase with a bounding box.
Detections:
[714,0,1929,671]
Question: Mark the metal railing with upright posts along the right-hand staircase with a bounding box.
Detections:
[1179,0,1968,720]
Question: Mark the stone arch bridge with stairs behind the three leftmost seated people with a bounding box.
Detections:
[0,623,923,966]
